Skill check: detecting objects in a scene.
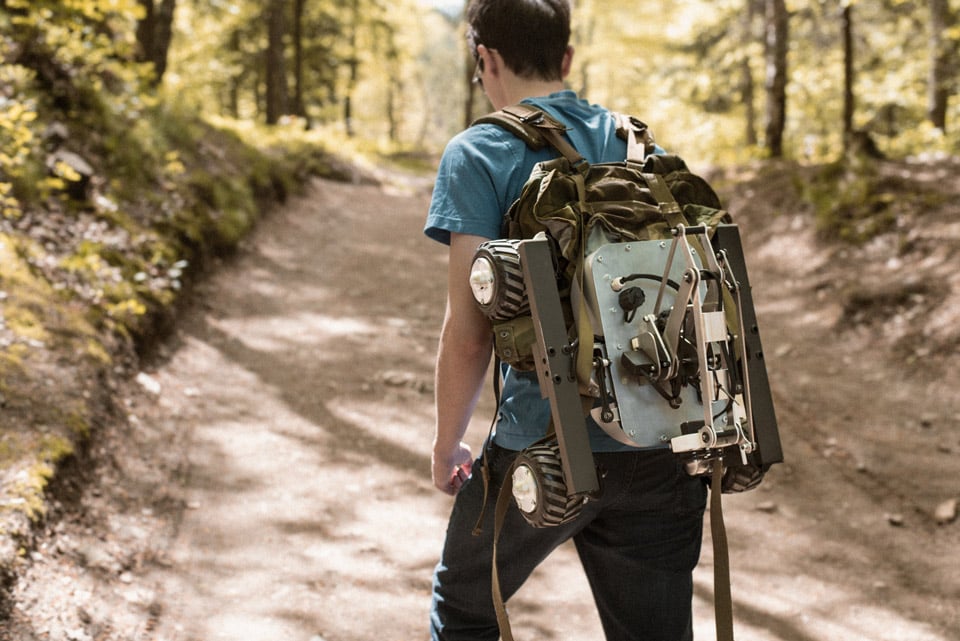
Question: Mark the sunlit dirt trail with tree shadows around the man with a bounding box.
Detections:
[1,172,960,641]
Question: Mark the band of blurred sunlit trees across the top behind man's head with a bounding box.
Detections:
[0,0,960,161]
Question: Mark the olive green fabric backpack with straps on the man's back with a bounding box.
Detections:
[474,104,730,387]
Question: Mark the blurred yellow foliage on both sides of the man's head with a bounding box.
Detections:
[156,0,960,163]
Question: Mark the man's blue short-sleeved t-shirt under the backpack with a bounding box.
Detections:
[424,91,633,452]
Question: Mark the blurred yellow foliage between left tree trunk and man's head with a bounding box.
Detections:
[164,0,466,148]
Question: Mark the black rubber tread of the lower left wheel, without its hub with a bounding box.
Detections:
[511,442,584,527]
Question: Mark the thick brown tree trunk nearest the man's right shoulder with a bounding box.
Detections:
[765,0,789,158]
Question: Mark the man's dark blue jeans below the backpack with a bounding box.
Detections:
[430,445,707,641]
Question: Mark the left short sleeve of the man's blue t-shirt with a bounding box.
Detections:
[423,125,523,244]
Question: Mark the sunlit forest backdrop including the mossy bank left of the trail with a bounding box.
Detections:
[0,0,960,616]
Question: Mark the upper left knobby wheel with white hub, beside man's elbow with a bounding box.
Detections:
[470,240,530,321]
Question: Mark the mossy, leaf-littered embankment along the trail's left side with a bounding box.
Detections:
[0,99,352,616]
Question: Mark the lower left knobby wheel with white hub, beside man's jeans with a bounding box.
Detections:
[511,441,585,527]
